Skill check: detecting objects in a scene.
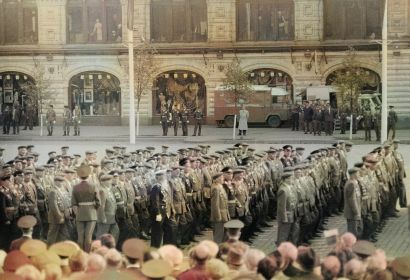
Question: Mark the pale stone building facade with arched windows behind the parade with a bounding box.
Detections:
[0,0,410,125]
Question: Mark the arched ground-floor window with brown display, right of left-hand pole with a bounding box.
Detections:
[152,70,206,115]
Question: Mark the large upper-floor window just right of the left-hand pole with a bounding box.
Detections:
[151,0,208,42]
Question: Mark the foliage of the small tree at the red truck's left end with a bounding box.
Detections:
[222,59,253,107]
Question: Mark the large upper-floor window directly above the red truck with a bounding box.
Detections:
[236,0,294,41]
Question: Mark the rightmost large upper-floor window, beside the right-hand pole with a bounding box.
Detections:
[324,0,383,40]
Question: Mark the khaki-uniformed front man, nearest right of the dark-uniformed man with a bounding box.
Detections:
[210,173,230,244]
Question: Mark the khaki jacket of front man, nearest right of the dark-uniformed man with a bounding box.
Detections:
[210,184,230,223]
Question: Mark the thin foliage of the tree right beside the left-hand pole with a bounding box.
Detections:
[134,41,158,110]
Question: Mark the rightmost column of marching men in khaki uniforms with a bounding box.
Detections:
[344,139,407,241]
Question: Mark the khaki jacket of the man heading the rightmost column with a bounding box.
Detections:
[344,180,362,221]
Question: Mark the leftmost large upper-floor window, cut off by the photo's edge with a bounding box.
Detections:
[0,0,38,44]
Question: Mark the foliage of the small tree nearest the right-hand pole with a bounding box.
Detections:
[332,48,370,112]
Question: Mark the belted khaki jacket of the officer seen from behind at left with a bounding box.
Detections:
[71,181,100,222]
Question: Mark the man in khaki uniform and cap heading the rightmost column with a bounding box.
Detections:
[344,168,363,238]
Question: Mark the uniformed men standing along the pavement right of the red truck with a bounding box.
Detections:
[291,100,398,142]
